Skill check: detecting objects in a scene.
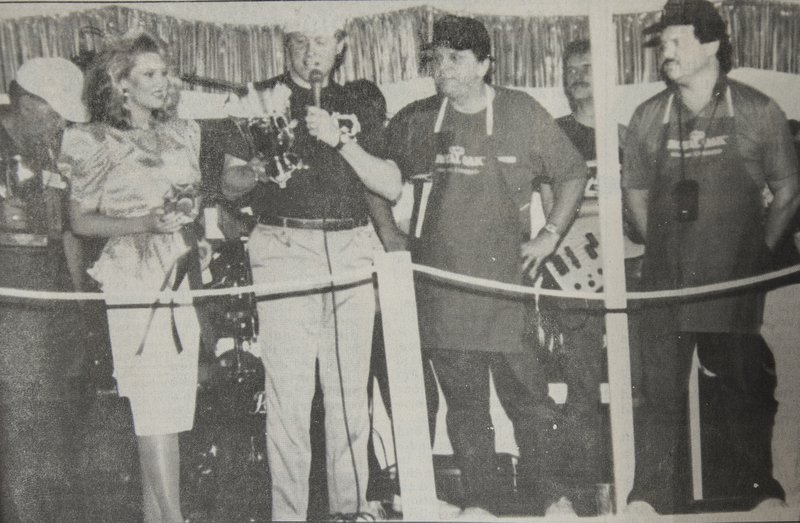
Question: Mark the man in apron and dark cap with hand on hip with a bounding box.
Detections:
[387,16,587,511]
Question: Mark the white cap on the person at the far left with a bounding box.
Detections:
[16,58,89,123]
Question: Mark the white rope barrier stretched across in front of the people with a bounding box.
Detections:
[0,263,800,305]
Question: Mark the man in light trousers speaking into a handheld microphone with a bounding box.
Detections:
[222,13,401,520]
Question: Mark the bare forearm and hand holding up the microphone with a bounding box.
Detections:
[306,106,403,202]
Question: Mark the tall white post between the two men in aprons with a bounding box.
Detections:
[589,1,634,512]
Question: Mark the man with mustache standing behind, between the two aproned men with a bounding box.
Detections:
[539,40,611,515]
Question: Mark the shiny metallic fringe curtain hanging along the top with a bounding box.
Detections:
[0,0,800,92]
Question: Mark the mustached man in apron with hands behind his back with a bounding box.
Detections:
[622,0,798,514]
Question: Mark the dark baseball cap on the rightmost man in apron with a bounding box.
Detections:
[643,0,727,47]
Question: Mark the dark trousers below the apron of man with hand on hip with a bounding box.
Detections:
[429,349,561,512]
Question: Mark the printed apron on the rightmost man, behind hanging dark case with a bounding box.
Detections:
[642,90,768,333]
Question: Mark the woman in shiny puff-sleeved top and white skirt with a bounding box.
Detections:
[59,33,200,522]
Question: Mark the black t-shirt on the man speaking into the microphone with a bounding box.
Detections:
[231,73,384,220]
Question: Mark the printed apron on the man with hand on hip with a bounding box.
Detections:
[414,95,525,352]
